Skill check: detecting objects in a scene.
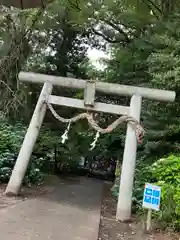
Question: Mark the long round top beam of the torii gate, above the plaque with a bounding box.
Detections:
[19,72,176,102]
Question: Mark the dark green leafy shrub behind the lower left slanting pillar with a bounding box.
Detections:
[0,122,44,185]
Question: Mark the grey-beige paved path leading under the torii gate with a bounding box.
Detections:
[0,177,103,240]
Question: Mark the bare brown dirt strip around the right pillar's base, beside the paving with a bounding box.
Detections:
[98,183,180,240]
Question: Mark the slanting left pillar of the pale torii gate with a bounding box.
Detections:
[5,82,53,195]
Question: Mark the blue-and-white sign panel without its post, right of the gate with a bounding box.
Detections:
[143,183,161,211]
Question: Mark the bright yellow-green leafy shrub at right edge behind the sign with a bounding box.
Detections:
[150,155,180,229]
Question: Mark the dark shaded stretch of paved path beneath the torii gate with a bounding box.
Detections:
[40,177,104,210]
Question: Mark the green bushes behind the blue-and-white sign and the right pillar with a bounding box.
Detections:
[111,155,180,230]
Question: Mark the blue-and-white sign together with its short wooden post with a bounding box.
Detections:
[143,183,161,231]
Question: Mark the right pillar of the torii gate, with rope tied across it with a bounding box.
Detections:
[116,95,142,221]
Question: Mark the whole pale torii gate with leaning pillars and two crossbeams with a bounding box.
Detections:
[5,72,176,221]
